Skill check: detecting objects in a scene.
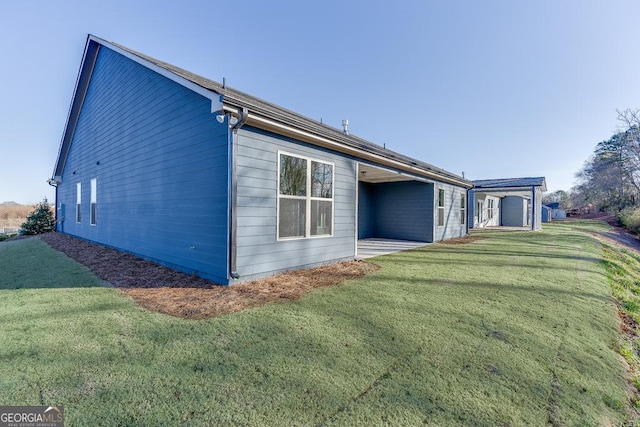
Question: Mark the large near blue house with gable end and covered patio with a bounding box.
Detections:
[49,35,472,285]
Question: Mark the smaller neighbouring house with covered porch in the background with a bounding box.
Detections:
[469,177,547,230]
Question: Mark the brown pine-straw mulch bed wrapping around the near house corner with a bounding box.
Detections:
[40,233,380,319]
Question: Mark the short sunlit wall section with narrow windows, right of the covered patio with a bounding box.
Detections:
[432,182,469,242]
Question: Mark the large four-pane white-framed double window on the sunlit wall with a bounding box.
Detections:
[278,153,333,239]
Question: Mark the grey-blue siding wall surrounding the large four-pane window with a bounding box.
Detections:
[236,127,356,281]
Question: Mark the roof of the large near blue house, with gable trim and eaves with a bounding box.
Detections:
[53,35,472,188]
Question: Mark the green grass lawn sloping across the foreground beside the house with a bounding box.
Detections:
[0,226,631,426]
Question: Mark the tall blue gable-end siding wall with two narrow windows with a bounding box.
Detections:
[57,47,228,283]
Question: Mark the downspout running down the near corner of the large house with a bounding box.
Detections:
[227,107,249,279]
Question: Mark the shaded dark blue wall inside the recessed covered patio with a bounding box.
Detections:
[370,181,434,242]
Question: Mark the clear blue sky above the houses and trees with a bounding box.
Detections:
[0,0,640,203]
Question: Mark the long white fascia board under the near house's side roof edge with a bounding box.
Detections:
[223,105,471,188]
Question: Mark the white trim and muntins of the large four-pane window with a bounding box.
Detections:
[276,150,336,242]
